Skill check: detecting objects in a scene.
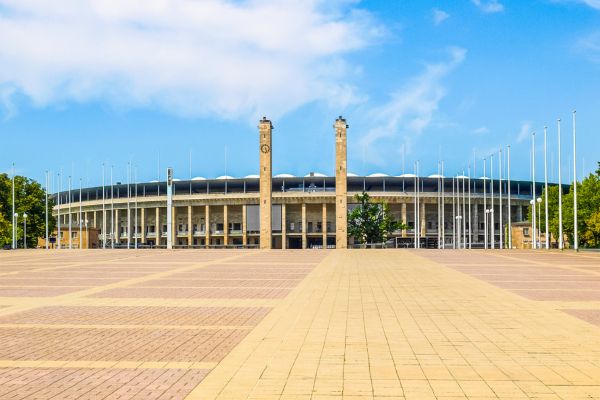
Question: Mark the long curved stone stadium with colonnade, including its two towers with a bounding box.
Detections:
[53,117,543,249]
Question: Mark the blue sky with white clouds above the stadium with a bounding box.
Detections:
[0,0,600,189]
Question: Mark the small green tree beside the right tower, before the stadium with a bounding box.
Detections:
[348,192,404,244]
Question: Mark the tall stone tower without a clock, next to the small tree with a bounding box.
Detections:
[334,115,348,249]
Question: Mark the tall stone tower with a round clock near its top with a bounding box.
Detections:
[258,117,273,249]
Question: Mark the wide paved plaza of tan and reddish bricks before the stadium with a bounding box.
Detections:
[0,250,600,400]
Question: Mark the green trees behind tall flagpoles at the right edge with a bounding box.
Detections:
[529,163,600,247]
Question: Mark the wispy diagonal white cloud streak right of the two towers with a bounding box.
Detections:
[360,48,466,165]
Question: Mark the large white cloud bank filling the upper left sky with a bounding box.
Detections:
[0,0,381,118]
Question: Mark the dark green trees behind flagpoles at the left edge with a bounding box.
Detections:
[0,174,56,247]
